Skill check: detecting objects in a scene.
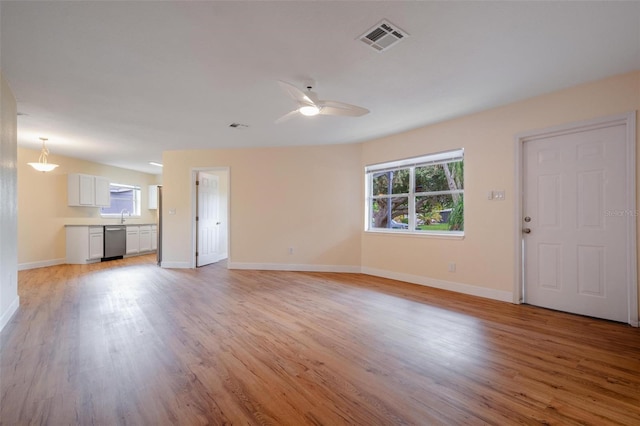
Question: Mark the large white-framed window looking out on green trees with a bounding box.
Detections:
[365,149,464,235]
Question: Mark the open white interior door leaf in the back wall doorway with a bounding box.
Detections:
[196,172,225,266]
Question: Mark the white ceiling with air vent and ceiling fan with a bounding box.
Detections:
[0,1,640,173]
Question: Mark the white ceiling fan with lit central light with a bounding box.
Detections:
[276,81,369,123]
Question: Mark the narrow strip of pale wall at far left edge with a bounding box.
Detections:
[0,73,20,330]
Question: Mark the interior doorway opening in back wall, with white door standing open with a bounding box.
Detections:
[193,169,229,268]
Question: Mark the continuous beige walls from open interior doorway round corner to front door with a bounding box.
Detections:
[163,72,640,322]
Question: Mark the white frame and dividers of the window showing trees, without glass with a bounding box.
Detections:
[364,148,464,237]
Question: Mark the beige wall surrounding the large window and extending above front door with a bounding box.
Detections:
[361,72,640,306]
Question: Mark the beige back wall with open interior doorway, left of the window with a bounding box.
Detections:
[163,145,362,270]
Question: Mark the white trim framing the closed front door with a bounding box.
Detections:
[513,111,640,327]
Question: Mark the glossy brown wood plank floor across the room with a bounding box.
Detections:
[0,256,640,425]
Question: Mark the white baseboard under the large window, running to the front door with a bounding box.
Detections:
[362,267,513,303]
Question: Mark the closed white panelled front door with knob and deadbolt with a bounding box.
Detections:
[521,120,636,322]
